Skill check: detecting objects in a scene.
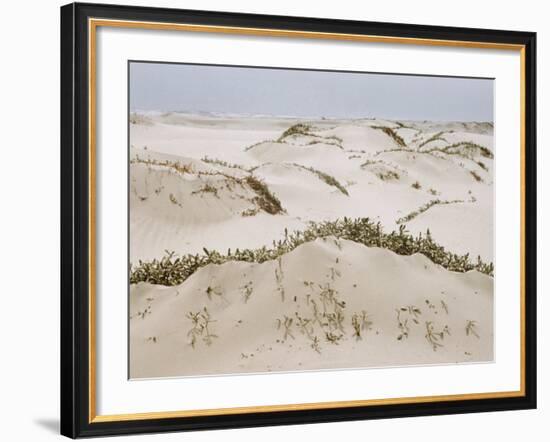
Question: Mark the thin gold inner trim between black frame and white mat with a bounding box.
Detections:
[88,18,526,423]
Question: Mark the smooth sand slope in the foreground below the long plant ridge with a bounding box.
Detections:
[130,237,493,377]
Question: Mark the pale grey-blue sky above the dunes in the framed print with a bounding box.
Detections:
[130,62,494,121]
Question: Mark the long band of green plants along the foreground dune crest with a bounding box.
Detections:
[130,218,494,286]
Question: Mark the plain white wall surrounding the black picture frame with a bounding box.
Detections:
[0,0,550,442]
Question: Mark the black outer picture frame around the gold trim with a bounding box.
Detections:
[60,3,537,438]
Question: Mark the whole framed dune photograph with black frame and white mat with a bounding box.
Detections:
[61,4,536,438]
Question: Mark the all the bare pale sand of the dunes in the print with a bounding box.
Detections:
[130,114,493,377]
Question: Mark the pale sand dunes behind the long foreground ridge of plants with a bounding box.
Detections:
[130,114,493,261]
